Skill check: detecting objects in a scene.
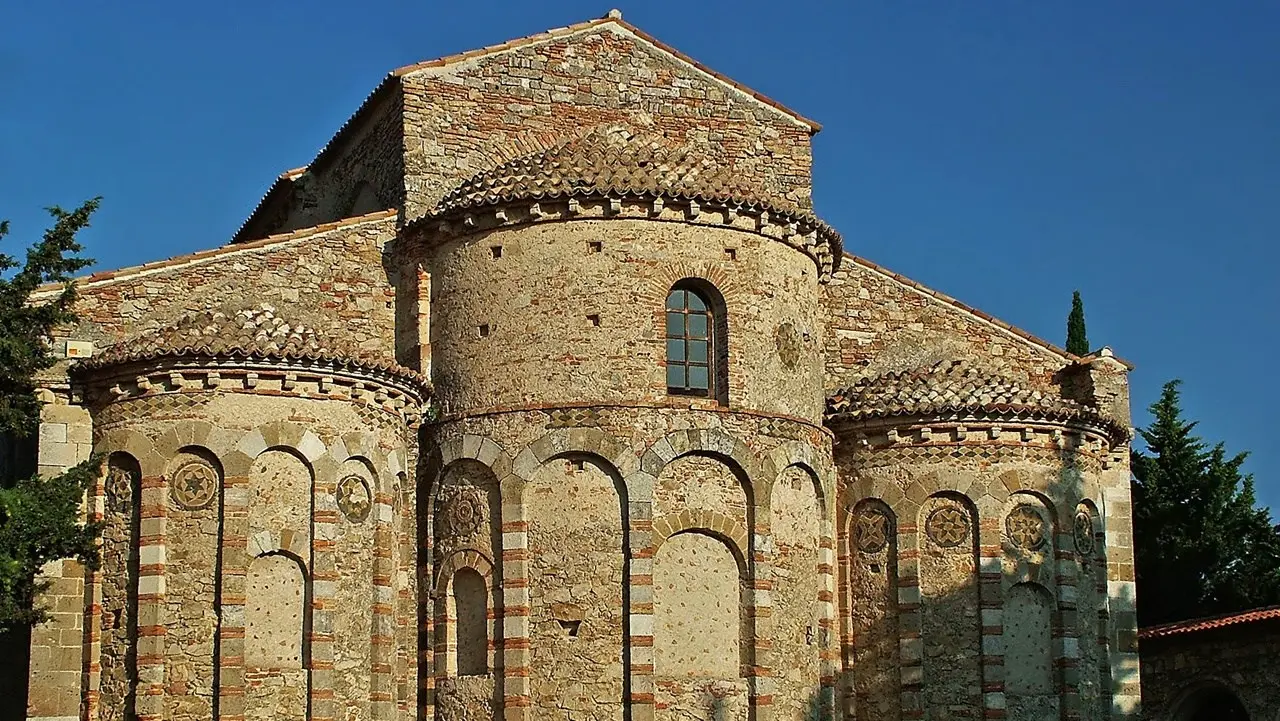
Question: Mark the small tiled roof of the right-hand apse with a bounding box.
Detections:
[827,360,1121,435]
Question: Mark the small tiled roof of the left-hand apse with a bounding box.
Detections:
[74,305,428,388]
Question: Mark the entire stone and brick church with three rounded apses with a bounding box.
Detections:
[22,13,1139,721]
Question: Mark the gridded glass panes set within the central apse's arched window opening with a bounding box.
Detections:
[667,287,716,397]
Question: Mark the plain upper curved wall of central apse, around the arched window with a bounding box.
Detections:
[426,219,822,421]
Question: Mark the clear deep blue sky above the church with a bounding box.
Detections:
[0,0,1280,506]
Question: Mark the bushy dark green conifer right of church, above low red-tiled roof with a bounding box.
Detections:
[1132,380,1280,625]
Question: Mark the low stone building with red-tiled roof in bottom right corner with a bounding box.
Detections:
[1138,606,1280,721]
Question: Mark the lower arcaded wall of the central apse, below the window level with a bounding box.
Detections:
[422,405,835,721]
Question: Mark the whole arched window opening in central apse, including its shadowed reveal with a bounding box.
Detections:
[667,280,728,402]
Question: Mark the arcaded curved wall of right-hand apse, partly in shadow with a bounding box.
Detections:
[836,423,1119,720]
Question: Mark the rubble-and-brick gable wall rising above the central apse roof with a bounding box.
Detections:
[403,23,813,219]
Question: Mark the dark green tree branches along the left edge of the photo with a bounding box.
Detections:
[0,198,100,634]
